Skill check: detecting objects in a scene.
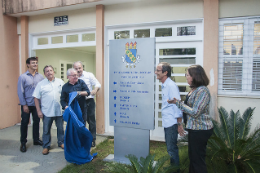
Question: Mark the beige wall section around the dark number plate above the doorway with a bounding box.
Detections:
[29,8,96,34]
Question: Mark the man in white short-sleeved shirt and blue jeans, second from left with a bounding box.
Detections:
[33,65,64,155]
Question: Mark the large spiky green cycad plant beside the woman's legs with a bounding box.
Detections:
[207,107,260,173]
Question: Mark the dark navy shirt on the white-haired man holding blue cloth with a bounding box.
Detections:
[60,79,90,112]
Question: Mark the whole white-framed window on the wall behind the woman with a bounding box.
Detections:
[218,17,260,96]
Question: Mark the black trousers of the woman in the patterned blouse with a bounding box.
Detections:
[188,129,213,173]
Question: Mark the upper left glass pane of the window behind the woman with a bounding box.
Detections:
[223,24,244,55]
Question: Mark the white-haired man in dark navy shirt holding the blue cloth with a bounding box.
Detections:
[60,68,90,113]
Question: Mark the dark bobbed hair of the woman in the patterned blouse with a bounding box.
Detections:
[188,65,209,88]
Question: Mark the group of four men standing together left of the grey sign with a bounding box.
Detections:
[17,57,101,155]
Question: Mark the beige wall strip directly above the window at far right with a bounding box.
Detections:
[219,0,260,18]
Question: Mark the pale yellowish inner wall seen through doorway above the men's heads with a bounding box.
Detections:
[36,49,96,78]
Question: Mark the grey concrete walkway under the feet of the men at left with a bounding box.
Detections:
[0,125,106,173]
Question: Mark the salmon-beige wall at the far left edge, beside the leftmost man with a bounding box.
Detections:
[0,0,21,128]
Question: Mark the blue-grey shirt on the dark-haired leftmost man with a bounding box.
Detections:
[17,70,44,106]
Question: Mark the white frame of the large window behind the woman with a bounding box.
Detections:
[218,16,260,97]
